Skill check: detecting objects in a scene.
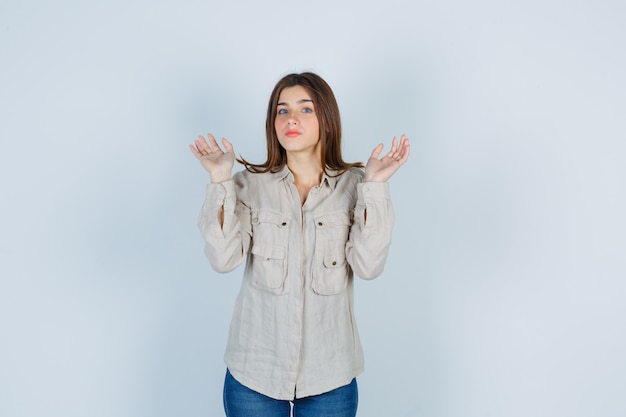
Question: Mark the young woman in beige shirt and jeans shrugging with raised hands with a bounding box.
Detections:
[190,73,409,417]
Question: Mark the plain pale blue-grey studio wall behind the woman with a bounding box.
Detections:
[0,0,626,417]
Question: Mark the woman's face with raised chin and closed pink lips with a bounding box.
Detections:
[274,85,320,157]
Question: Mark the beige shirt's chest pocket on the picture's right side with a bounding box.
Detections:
[311,210,352,295]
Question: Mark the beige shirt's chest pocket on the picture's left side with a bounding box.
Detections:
[247,209,291,294]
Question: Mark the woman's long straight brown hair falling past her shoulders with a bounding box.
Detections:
[237,72,363,174]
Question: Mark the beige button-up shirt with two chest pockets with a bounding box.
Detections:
[199,167,394,400]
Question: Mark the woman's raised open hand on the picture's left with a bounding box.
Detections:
[189,133,235,183]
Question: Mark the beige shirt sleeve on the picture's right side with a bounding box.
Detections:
[346,182,394,279]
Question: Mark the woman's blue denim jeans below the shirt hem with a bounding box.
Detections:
[224,370,359,417]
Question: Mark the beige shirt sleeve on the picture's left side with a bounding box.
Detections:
[198,176,251,272]
